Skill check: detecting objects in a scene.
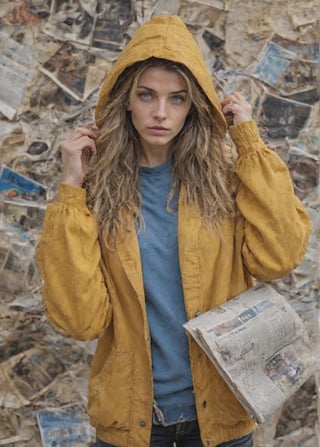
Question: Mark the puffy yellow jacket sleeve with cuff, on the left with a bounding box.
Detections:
[36,184,112,340]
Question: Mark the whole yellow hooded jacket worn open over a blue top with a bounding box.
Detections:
[37,16,310,447]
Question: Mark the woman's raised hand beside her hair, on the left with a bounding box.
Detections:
[61,125,97,187]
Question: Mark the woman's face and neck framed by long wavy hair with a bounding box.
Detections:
[128,67,191,165]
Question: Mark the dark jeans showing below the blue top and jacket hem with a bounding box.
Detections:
[94,421,253,447]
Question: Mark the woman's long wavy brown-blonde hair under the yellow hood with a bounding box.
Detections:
[83,58,234,247]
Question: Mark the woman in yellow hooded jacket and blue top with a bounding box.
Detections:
[37,16,310,447]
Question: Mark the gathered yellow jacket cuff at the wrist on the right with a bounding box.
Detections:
[229,120,264,155]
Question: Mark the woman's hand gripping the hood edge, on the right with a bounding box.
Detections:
[221,92,252,127]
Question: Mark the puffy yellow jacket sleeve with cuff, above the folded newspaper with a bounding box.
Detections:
[229,121,310,281]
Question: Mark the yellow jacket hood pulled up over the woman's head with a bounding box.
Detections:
[96,16,227,134]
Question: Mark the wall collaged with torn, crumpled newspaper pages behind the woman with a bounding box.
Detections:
[0,0,320,447]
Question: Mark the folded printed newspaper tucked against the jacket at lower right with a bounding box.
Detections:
[184,284,315,424]
